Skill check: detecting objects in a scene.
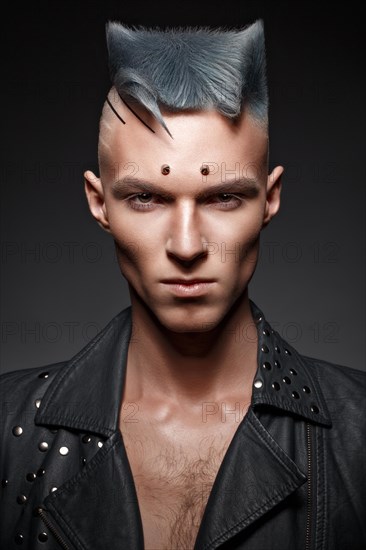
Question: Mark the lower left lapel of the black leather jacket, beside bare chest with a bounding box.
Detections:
[44,432,144,550]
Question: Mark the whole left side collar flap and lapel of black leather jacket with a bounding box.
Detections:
[35,307,143,550]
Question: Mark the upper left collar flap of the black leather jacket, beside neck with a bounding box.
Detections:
[35,307,132,436]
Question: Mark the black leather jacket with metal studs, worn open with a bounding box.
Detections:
[0,302,366,550]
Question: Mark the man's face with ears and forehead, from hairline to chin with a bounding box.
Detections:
[85,92,282,332]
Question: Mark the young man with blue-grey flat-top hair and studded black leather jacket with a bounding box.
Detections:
[0,21,366,550]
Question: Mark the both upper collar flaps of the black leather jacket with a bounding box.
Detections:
[35,301,332,436]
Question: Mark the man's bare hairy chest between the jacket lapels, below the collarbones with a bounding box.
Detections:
[121,406,249,550]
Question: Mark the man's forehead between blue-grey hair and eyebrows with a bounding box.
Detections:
[99,92,268,181]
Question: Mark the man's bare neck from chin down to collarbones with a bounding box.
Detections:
[125,289,257,404]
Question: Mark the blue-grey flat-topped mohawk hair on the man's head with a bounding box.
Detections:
[106,20,268,137]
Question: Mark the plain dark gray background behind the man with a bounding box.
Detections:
[1,0,365,372]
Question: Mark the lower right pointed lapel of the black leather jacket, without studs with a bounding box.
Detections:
[195,407,307,550]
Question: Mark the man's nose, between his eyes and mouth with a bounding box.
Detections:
[166,202,207,262]
